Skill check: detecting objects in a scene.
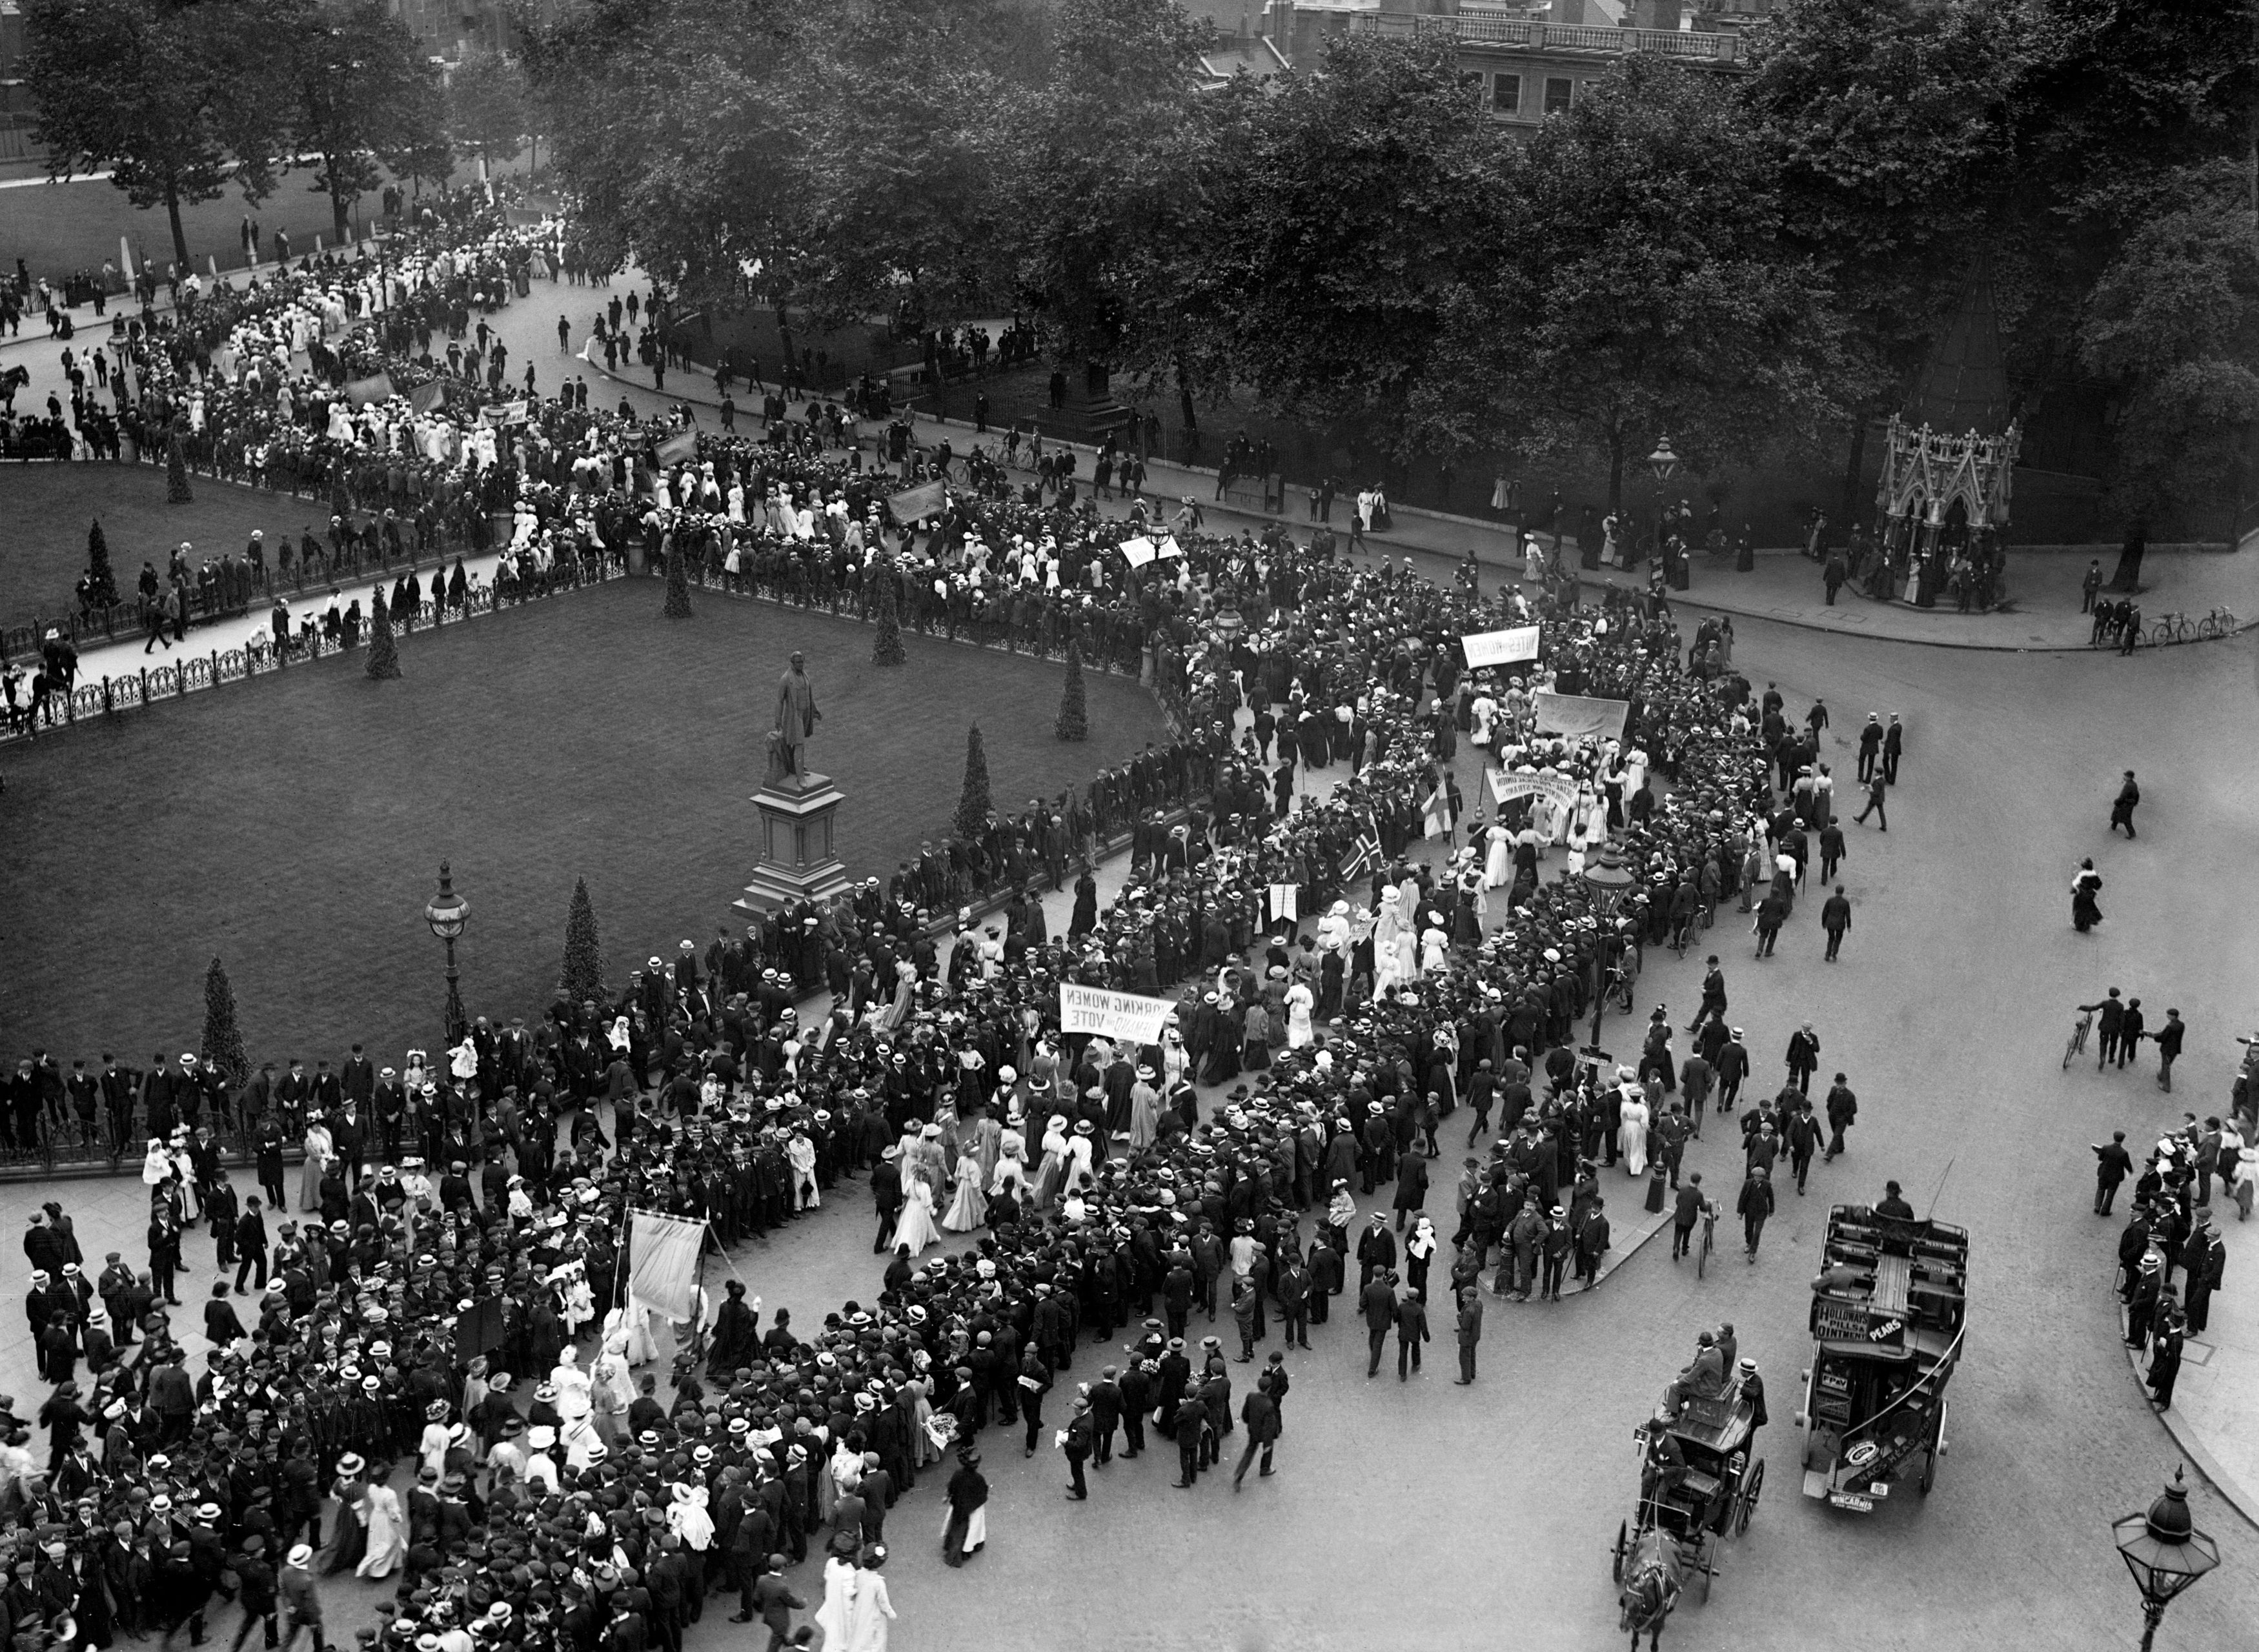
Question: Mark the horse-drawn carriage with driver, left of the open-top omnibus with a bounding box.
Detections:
[1613,1374,1765,1652]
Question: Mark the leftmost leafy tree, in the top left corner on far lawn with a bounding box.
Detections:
[23,0,283,265]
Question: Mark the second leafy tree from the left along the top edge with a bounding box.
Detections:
[289,0,445,242]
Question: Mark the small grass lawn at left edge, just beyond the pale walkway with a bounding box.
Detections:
[0,463,411,650]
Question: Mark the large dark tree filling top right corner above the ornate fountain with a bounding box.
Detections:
[1744,0,2254,524]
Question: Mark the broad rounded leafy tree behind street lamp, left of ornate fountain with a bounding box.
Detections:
[1417,54,1834,509]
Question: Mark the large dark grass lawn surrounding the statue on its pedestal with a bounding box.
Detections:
[0,581,1164,1069]
